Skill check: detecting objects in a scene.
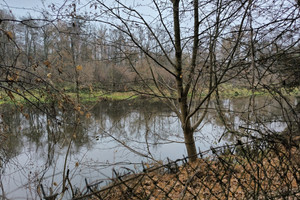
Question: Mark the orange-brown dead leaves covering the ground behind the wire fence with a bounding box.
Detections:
[94,145,300,199]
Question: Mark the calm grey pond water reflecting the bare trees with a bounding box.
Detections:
[0,97,297,199]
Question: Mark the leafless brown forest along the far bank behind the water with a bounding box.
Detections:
[0,3,300,94]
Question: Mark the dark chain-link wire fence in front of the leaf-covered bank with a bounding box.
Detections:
[73,139,300,200]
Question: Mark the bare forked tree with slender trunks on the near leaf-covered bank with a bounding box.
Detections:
[85,0,262,161]
